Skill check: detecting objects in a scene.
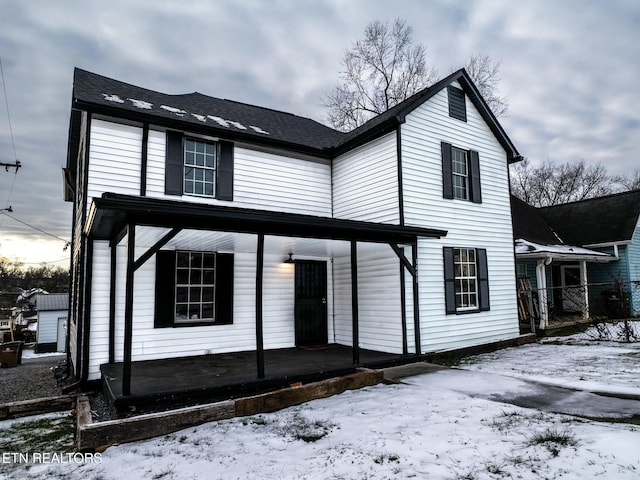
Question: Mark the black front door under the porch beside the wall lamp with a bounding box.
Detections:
[295,261,327,345]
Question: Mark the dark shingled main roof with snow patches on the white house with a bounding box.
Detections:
[68,68,521,165]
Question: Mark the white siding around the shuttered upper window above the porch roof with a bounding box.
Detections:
[147,130,331,217]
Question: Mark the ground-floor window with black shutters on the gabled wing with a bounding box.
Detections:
[444,247,489,313]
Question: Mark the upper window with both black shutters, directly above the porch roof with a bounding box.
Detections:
[164,131,234,200]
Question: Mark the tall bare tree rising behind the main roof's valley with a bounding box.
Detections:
[325,18,436,131]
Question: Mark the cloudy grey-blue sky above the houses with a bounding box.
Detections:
[0,0,640,266]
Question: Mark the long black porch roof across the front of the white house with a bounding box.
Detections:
[85,193,447,244]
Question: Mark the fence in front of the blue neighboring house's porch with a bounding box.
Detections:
[518,278,640,331]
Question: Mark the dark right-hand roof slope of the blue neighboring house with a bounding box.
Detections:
[539,190,640,246]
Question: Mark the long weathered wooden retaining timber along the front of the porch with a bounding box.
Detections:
[76,370,384,451]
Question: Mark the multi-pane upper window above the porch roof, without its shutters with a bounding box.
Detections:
[183,138,216,197]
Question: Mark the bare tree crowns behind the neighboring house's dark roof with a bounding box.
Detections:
[511,159,615,207]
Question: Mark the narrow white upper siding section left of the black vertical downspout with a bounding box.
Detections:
[87,119,142,208]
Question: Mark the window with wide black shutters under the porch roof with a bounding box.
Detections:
[154,251,233,328]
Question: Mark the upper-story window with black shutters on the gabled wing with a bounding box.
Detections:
[441,142,482,203]
